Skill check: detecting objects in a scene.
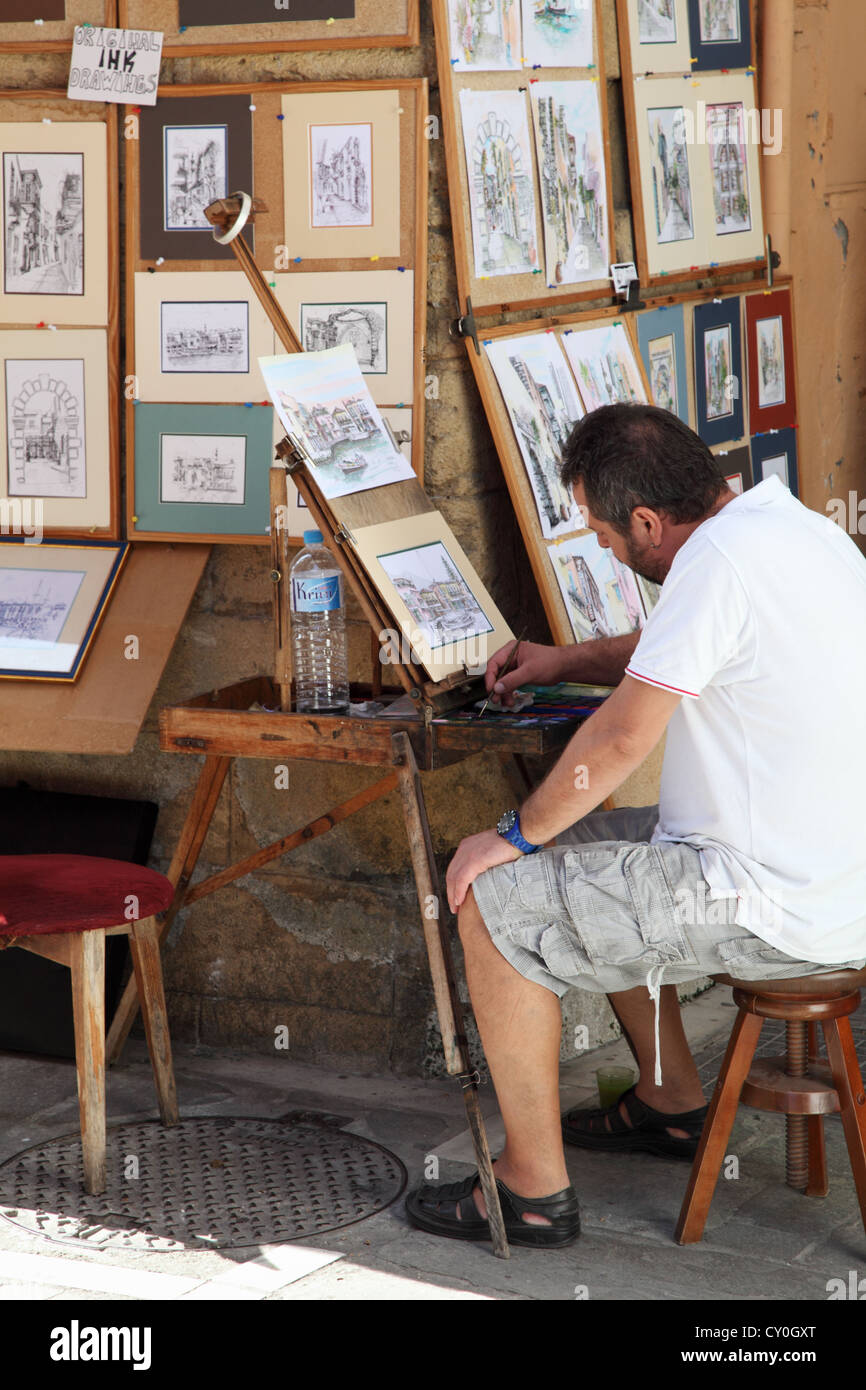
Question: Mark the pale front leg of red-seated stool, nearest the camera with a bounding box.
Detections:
[70,930,106,1197]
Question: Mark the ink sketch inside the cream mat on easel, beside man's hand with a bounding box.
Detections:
[377,541,493,651]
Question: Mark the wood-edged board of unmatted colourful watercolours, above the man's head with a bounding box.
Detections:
[432,0,616,314]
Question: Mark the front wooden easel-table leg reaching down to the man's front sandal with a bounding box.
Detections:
[391,734,510,1259]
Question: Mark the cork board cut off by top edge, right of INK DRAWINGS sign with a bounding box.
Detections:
[120,0,420,58]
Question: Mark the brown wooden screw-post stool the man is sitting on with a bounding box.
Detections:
[674,969,866,1245]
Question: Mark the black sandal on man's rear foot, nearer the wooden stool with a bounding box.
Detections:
[563,1086,709,1162]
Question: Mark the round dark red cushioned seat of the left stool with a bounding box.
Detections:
[0,855,174,937]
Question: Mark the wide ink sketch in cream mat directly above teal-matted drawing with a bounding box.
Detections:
[160,299,250,374]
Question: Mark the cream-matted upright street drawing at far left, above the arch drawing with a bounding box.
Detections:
[0,121,108,324]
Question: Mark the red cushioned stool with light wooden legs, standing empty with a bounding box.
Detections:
[0,855,178,1195]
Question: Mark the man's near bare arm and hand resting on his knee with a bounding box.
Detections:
[446,676,681,912]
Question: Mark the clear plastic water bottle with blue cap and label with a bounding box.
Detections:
[289,531,349,714]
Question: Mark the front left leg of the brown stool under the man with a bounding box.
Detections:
[674,1009,763,1245]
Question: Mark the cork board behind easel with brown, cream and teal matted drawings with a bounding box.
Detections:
[125,78,428,543]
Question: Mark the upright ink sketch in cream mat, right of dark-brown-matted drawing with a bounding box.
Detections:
[310,122,373,227]
